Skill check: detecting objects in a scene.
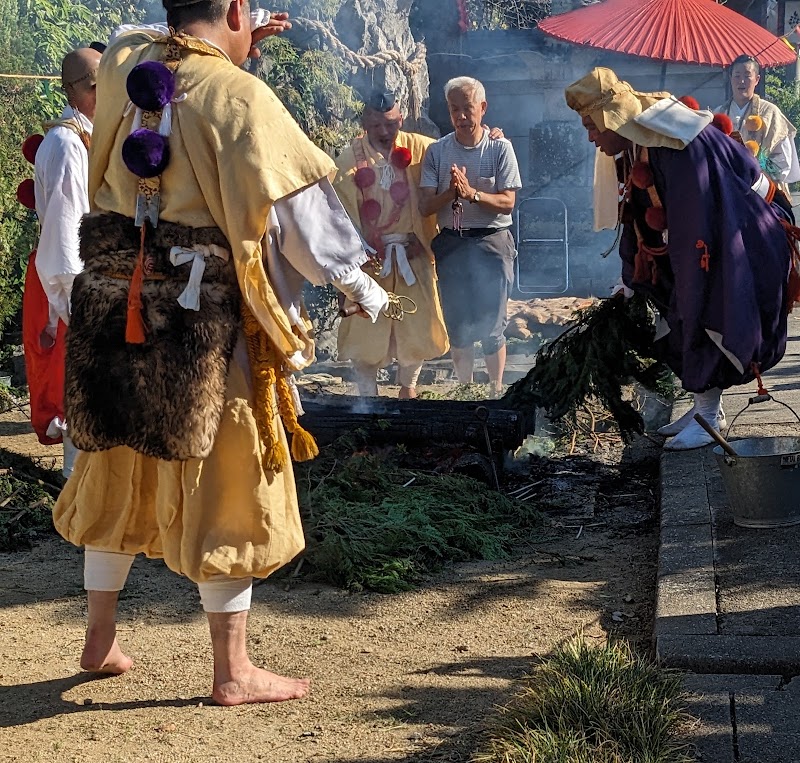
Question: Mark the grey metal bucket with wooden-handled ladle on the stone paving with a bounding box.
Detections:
[714,437,800,529]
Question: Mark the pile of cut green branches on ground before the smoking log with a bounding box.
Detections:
[296,439,538,593]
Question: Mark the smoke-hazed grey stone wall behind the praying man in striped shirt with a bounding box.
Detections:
[428,30,725,296]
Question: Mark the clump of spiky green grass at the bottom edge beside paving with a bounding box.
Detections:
[475,638,693,763]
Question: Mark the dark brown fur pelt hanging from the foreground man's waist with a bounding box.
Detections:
[65,213,241,461]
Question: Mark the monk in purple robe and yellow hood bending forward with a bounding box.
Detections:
[566,68,796,450]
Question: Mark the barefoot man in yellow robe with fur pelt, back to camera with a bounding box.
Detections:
[54,0,387,705]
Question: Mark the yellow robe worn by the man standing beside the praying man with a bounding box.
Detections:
[334,132,450,366]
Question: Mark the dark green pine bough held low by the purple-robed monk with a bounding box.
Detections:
[503,295,672,440]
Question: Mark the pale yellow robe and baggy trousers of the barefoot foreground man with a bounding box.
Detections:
[53,31,334,582]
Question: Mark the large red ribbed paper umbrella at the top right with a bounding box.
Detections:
[539,0,797,66]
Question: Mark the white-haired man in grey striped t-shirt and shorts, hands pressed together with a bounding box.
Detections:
[419,77,522,397]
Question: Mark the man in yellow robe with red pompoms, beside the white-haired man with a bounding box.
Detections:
[334,92,449,399]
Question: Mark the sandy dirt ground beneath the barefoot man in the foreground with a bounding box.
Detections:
[0,394,658,763]
